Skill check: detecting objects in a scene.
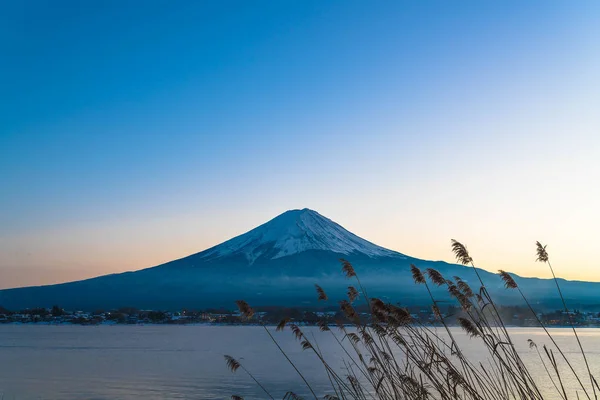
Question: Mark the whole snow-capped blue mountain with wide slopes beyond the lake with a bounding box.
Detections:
[0,209,600,310]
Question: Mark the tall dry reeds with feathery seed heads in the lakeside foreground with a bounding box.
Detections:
[225,240,600,400]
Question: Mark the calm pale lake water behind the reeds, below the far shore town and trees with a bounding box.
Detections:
[0,325,600,400]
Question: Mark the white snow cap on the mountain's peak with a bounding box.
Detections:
[202,208,404,263]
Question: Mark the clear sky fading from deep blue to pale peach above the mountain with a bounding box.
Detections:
[0,0,600,287]
